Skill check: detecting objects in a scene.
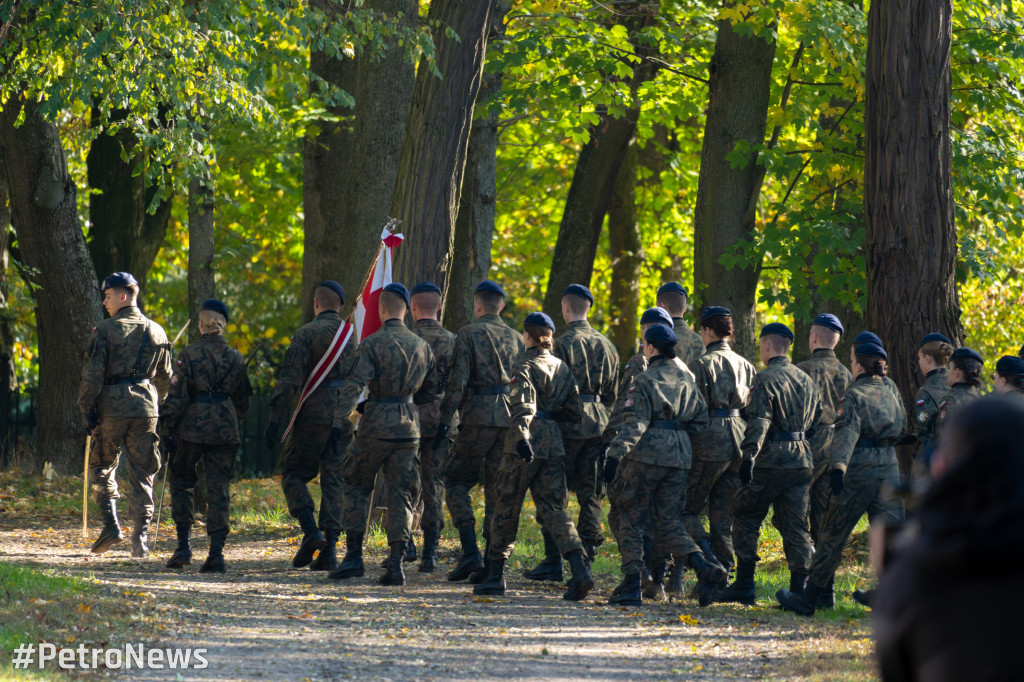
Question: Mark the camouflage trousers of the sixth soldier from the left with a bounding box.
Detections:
[444,426,508,539]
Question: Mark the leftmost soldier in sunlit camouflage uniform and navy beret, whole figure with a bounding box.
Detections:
[78,272,171,559]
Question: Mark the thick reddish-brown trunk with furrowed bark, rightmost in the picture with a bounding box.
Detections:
[864,0,964,403]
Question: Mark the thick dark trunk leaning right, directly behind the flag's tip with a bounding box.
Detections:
[391,0,494,301]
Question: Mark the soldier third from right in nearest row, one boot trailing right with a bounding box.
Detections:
[604,325,726,606]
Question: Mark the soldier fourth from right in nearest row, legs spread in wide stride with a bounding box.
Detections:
[473,312,594,601]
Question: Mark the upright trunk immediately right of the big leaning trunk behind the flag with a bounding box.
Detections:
[444,1,509,330]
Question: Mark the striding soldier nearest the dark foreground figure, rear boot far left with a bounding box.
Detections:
[776,343,906,615]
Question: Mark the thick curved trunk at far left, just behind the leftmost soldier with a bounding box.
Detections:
[0,95,101,471]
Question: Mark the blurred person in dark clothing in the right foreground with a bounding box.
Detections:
[871,397,1024,682]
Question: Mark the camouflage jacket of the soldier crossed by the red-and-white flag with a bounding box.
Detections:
[270,310,355,427]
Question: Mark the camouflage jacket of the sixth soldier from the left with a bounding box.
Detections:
[440,315,523,427]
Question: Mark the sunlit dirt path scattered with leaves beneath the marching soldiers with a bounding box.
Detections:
[0,519,866,680]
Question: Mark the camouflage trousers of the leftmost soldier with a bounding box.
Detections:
[89,417,160,521]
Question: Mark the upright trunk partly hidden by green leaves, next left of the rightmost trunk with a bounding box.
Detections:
[693,13,775,357]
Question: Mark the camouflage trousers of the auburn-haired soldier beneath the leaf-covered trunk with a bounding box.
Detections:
[682,460,739,570]
